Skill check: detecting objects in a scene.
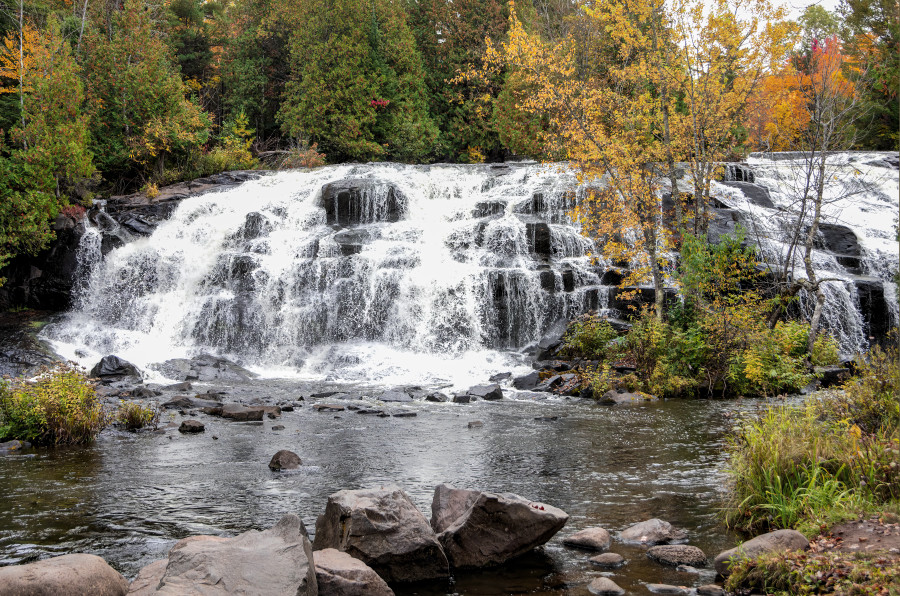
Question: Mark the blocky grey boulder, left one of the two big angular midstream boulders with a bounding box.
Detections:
[313,487,450,582]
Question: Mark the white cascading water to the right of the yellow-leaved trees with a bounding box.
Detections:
[714,152,900,357]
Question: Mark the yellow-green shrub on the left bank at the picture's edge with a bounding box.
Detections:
[0,364,108,445]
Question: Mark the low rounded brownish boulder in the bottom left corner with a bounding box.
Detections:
[0,553,128,596]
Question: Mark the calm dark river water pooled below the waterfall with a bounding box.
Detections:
[0,382,753,595]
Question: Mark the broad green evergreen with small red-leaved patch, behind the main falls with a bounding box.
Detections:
[279,0,437,161]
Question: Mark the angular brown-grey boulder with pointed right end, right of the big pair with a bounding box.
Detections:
[432,484,569,569]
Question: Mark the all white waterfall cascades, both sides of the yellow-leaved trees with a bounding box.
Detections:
[44,154,897,385]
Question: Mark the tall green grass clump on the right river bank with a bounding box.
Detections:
[724,338,900,534]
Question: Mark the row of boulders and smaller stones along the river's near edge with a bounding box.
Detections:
[0,484,806,596]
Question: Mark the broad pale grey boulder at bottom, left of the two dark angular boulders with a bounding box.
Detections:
[131,514,318,596]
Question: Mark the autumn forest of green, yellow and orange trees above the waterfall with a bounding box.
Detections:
[0,0,900,278]
